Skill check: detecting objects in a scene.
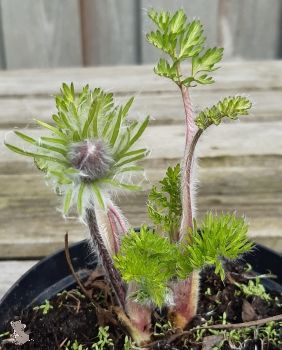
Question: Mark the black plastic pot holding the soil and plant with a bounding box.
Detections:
[0,240,282,334]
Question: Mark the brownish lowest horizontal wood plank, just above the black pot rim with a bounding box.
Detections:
[0,167,282,258]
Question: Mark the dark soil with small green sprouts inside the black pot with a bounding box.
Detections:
[0,262,282,350]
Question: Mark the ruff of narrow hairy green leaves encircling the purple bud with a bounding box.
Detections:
[6,84,149,215]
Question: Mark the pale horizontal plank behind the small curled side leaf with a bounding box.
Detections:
[0,89,282,130]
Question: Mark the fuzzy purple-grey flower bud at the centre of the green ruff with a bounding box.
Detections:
[68,139,113,180]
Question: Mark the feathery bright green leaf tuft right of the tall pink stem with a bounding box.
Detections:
[178,212,253,280]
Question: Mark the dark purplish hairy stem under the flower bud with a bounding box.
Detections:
[86,209,126,310]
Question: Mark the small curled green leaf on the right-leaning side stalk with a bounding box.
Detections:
[195,96,252,130]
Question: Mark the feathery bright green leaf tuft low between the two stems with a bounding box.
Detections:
[114,225,178,306]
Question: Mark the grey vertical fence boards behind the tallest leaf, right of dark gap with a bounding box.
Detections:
[141,0,282,63]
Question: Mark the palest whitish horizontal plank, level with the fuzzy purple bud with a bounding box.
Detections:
[0,121,282,171]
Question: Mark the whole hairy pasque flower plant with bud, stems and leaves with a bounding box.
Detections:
[6,9,253,345]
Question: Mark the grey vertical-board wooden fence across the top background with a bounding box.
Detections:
[0,0,282,69]
